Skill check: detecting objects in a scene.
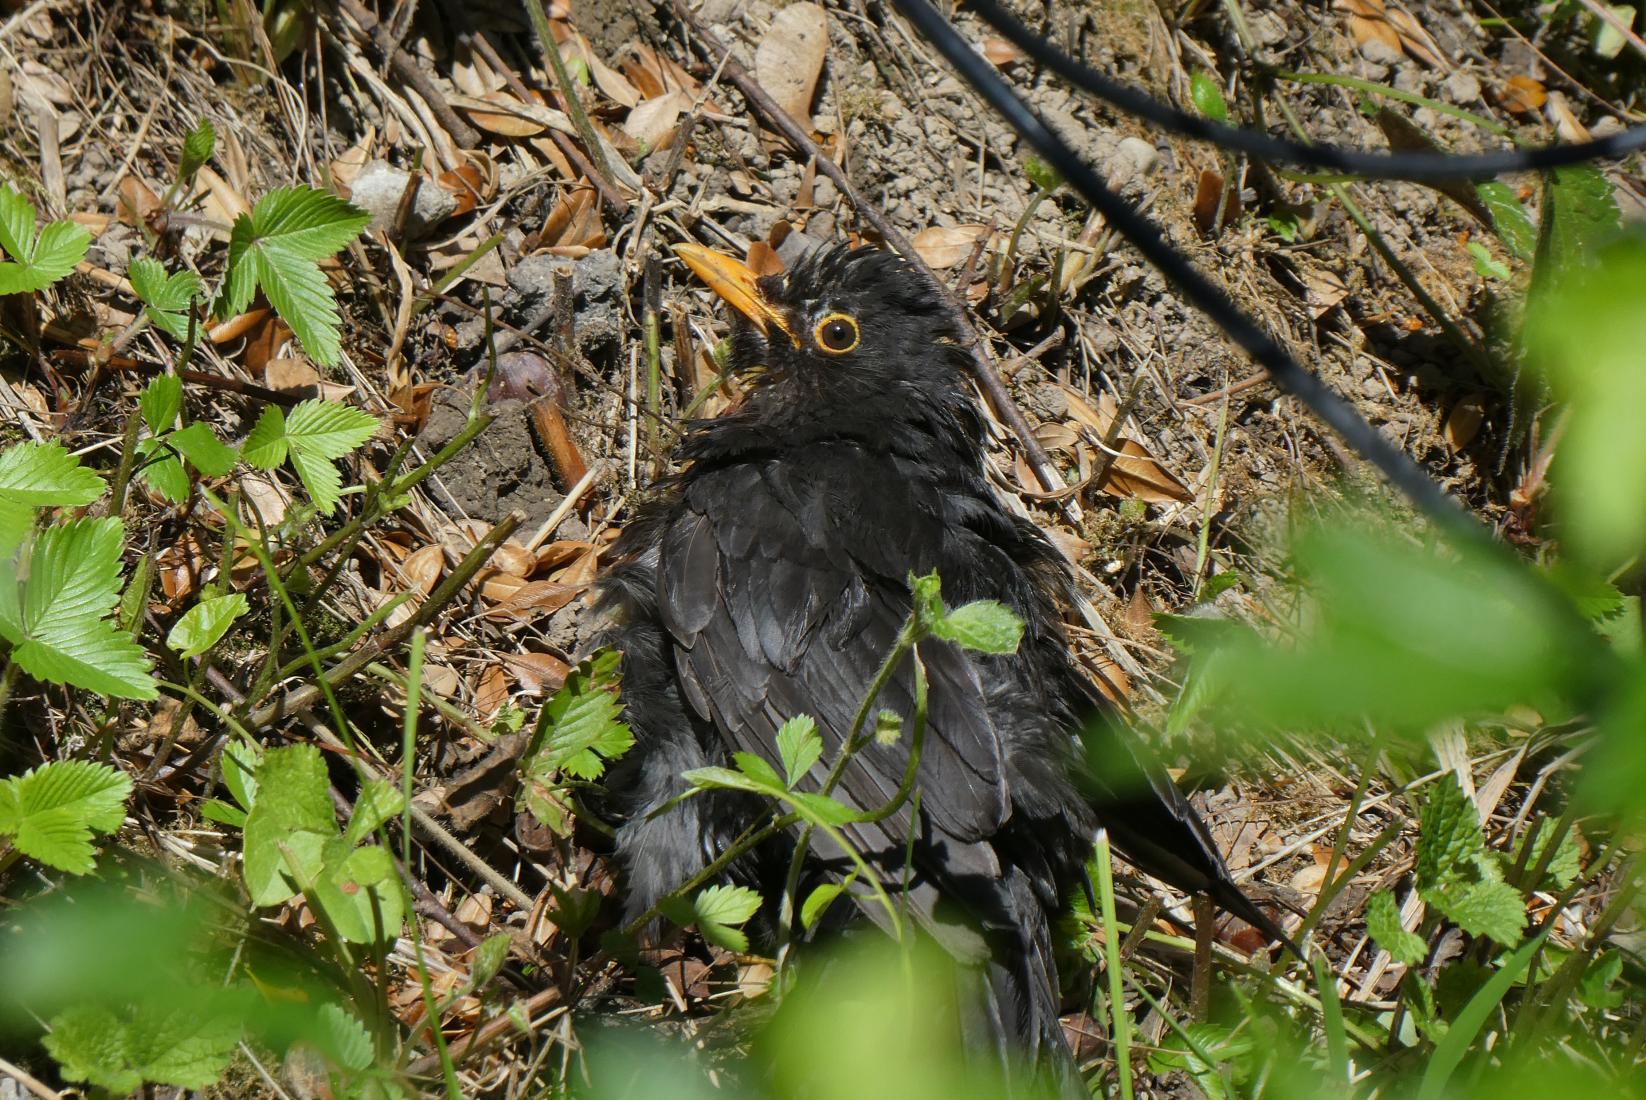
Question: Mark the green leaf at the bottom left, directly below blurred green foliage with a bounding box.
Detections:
[43,1004,240,1095]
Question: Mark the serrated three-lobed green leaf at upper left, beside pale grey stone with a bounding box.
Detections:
[217,188,370,367]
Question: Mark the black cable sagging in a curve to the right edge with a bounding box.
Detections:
[967,0,1646,181]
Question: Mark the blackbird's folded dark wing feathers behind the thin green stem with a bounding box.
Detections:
[658,463,1009,879]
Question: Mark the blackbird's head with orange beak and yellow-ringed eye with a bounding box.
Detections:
[675,245,965,418]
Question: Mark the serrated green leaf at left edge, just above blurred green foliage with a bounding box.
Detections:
[0,761,132,874]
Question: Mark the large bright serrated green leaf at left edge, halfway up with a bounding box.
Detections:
[0,517,156,698]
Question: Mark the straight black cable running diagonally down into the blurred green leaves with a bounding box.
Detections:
[892,0,1481,538]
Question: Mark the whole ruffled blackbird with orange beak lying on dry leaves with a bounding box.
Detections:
[602,245,1279,1069]
